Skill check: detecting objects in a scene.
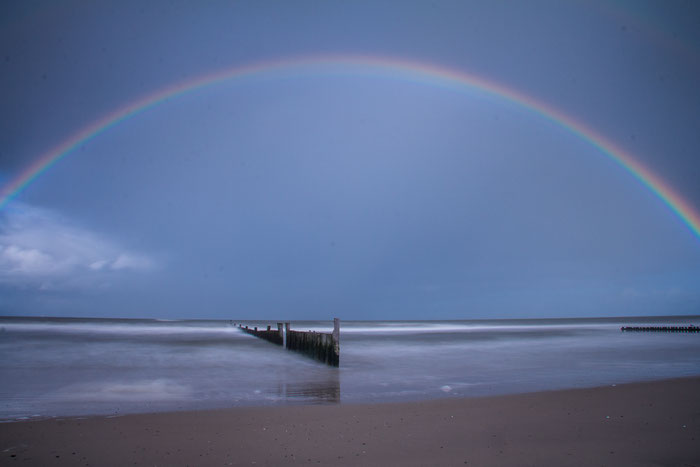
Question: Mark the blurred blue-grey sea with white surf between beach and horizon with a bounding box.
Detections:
[0,316,700,420]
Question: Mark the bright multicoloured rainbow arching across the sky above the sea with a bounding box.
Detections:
[0,56,700,239]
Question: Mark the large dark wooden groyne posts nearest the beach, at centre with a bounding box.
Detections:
[234,318,340,366]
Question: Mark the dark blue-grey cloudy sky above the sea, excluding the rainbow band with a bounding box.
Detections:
[0,0,700,319]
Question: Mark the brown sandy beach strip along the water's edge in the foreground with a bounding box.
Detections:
[0,377,700,467]
